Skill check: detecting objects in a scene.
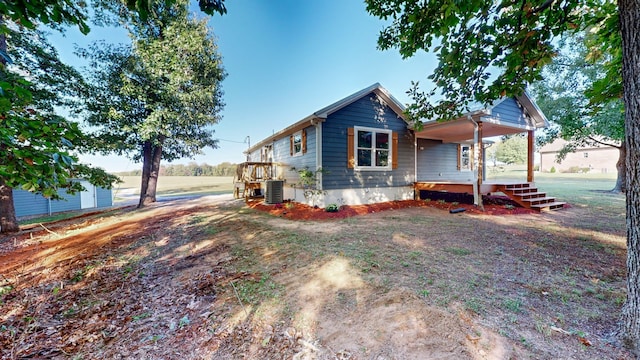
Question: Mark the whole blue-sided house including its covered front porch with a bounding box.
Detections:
[248,83,548,207]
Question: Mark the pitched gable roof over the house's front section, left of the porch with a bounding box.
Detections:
[246,83,406,153]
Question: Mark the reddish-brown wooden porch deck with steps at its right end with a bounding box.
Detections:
[414,181,565,211]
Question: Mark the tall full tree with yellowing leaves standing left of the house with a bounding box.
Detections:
[81,0,226,207]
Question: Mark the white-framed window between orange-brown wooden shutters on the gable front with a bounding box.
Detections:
[354,126,393,170]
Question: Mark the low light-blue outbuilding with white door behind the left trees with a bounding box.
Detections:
[13,181,113,217]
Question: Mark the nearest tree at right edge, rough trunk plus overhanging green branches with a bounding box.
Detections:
[366,0,640,356]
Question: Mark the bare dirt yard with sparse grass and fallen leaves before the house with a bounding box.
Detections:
[0,196,631,359]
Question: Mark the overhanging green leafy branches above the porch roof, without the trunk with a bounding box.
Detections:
[366,0,584,120]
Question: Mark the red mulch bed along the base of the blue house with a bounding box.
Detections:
[247,200,537,220]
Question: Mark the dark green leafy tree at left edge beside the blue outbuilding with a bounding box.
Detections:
[0,24,117,232]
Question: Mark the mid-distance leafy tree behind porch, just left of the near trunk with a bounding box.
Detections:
[533,34,626,192]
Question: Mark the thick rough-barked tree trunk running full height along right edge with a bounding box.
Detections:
[618,0,640,356]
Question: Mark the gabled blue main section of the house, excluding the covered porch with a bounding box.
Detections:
[248,84,415,207]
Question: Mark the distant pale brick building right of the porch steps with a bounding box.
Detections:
[539,139,620,174]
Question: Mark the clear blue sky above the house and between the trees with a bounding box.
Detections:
[52,0,436,171]
